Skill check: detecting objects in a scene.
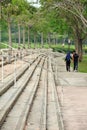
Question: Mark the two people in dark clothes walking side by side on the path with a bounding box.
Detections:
[65,51,79,71]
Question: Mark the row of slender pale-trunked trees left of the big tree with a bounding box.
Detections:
[0,0,58,47]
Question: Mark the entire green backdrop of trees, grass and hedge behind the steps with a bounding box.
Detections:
[0,0,87,72]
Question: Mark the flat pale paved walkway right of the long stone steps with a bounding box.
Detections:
[57,53,87,130]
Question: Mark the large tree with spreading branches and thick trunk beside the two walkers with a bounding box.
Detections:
[41,0,87,60]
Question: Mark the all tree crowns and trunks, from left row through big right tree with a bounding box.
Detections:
[0,0,87,60]
